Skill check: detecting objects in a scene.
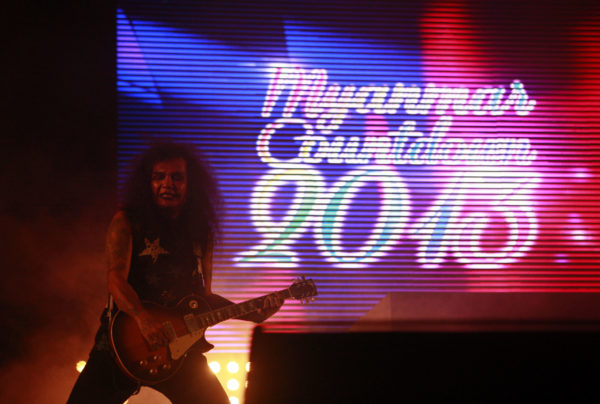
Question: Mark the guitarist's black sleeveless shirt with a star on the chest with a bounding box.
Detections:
[128,213,204,306]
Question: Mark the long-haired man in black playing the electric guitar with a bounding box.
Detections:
[68,143,283,404]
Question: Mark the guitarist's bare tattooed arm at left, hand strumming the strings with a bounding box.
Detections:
[106,211,169,345]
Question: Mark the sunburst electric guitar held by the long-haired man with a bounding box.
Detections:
[109,277,317,386]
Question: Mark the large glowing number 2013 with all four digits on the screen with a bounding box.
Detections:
[237,166,540,269]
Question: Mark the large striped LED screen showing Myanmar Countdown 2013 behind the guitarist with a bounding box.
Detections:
[116,0,600,353]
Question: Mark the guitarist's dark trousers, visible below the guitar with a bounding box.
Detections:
[67,348,229,404]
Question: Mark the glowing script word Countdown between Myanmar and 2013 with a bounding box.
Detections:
[256,116,537,167]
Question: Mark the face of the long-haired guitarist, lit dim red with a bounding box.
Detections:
[151,158,187,214]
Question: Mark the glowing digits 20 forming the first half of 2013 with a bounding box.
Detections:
[238,166,409,267]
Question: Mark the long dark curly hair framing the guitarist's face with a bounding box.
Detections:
[122,141,221,248]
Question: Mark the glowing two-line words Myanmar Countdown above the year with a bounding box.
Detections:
[257,66,537,166]
